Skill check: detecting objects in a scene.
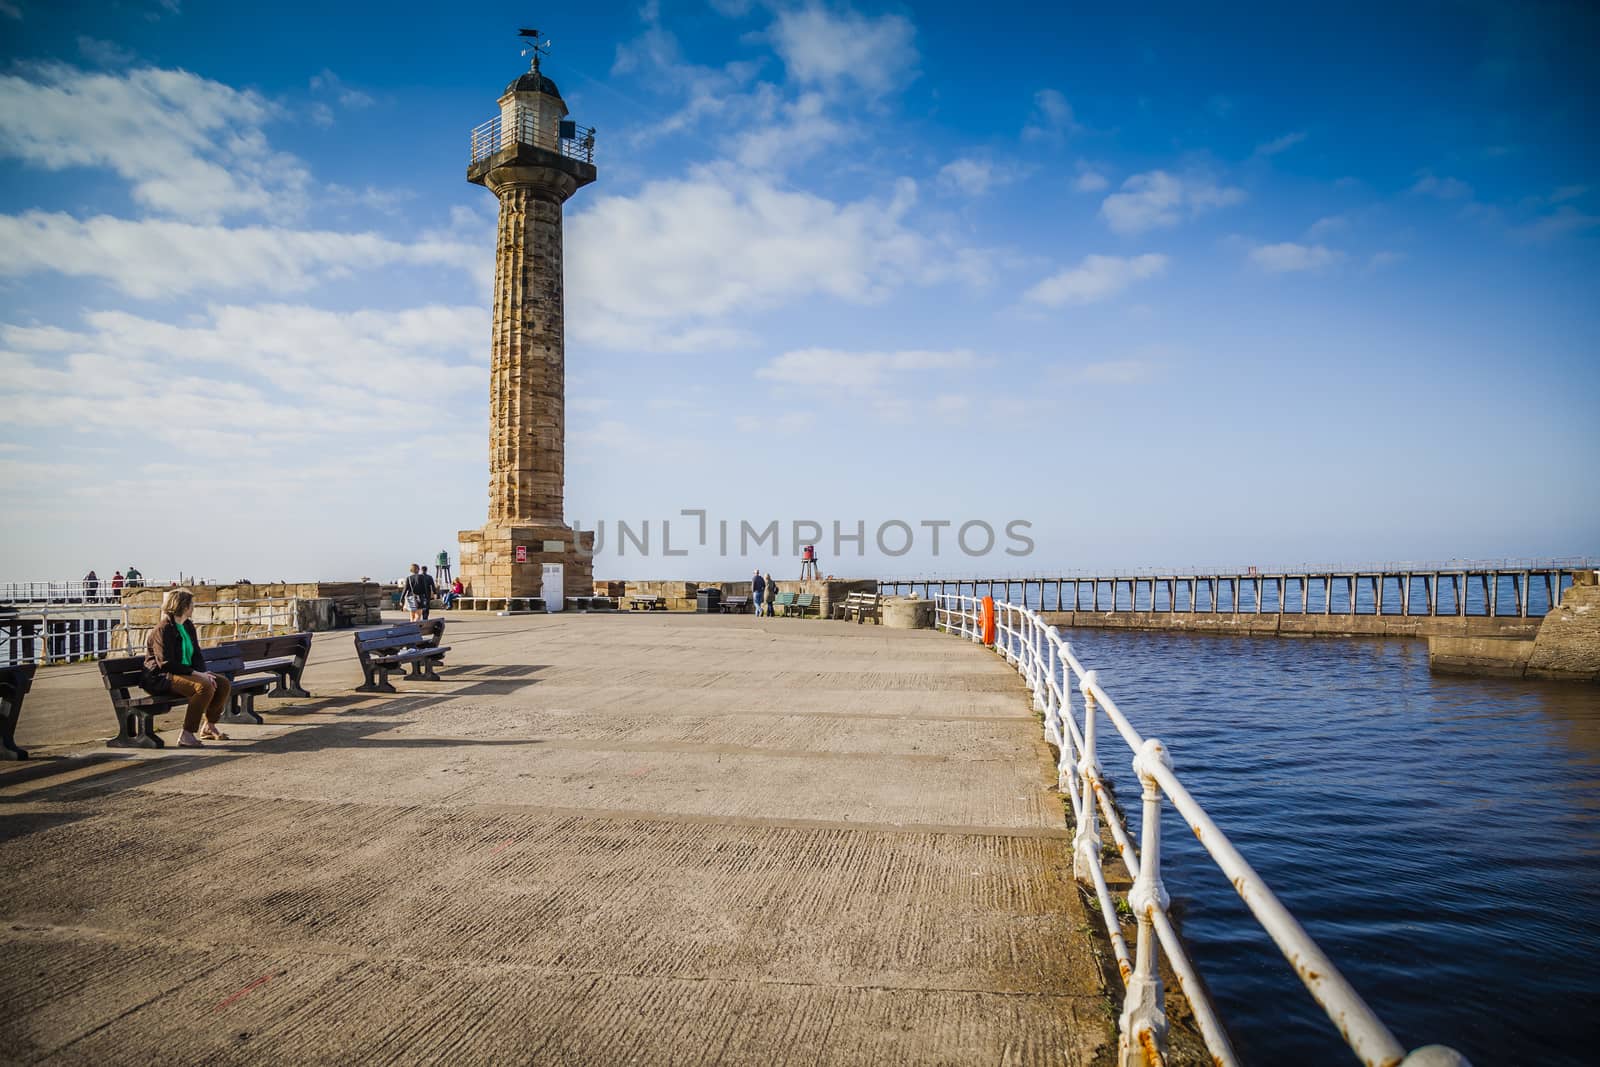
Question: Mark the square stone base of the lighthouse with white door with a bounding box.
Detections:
[456,523,595,598]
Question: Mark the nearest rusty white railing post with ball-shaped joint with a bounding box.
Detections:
[1117,737,1173,1067]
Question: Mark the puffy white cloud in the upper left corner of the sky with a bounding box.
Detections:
[0,64,309,221]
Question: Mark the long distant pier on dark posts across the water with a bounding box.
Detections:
[878,558,1600,619]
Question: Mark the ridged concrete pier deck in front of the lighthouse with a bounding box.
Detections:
[0,616,1115,1065]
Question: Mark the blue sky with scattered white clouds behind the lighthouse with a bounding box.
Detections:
[0,0,1600,579]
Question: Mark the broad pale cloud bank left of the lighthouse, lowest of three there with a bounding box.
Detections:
[0,304,490,451]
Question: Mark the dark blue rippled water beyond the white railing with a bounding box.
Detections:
[1067,630,1600,1067]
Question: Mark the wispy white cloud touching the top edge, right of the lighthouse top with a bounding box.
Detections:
[768,5,918,96]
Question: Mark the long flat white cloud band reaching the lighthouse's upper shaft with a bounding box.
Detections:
[0,211,476,299]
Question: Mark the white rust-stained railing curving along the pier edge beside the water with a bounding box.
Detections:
[934,593,1467,1067]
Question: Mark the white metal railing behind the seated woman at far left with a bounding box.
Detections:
[0,597,299,665]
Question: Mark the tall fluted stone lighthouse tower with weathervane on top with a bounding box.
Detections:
[461,30,595,598]
